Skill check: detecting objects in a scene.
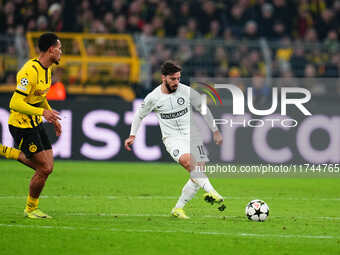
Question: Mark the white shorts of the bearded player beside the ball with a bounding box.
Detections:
[164,137,209,163]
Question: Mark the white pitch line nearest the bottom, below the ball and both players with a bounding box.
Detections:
[0,224,340,240]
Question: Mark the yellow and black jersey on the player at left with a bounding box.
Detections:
[8,59,51,128]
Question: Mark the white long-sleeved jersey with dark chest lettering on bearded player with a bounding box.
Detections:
[130,83,217,140]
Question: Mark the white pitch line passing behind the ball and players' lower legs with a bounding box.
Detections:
[0,195,340,201]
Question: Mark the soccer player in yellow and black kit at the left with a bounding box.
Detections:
[0,33,62,219]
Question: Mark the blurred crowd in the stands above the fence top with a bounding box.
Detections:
[0,0,340,42]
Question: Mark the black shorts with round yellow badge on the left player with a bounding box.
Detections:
[8,124,52,158]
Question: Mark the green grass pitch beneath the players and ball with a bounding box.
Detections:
[0,160,340,255]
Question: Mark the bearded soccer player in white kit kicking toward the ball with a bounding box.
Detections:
[125,61,223,219]
